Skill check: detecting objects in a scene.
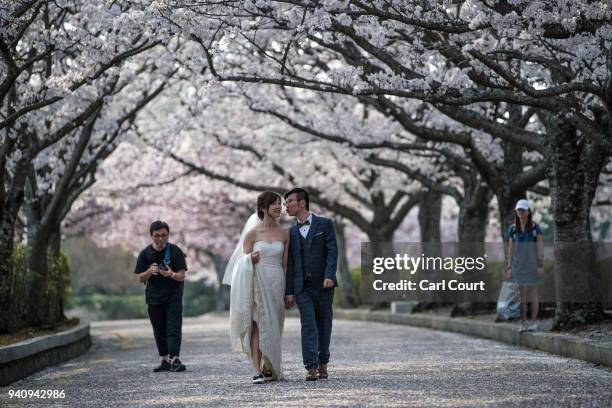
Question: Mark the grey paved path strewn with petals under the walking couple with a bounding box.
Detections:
[0,315,612,408]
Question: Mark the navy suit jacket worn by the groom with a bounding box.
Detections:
[285,214,338,295]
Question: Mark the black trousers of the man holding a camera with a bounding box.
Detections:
[148,302,183,358]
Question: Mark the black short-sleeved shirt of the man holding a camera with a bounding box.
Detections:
[134,243,187,305]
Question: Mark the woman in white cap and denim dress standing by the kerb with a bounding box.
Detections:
[506,199,544,331]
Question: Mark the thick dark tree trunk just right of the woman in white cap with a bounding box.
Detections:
[546,115,607,330]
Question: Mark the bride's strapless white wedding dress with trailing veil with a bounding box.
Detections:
[223,223,285,380]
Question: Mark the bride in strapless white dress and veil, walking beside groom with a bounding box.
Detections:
[223,191,289,384]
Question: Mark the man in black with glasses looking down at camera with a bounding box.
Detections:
[134,221,187,372]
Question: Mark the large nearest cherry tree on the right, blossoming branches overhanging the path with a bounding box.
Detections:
[142,0,612,327]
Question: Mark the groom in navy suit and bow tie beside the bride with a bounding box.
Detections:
[285,188,338,381]
